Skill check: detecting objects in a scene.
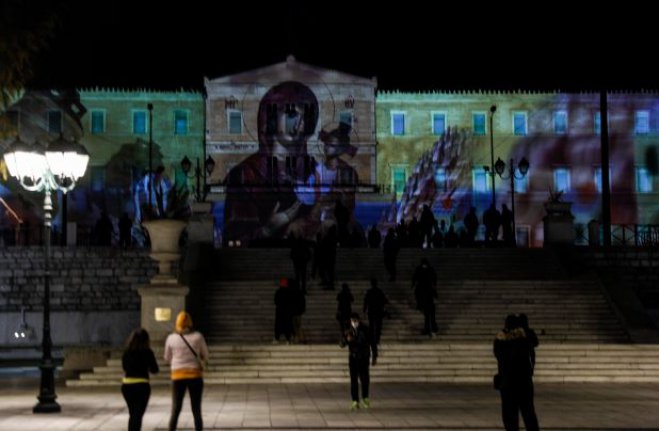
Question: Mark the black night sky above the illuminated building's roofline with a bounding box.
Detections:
[24,0,659,91]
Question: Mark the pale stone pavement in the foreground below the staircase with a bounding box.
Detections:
[0,377,659,431]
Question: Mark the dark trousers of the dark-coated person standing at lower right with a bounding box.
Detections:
[501,381,539,431]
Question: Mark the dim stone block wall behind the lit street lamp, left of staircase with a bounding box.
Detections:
[0,247,157,346]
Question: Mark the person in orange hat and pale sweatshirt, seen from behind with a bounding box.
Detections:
[165,311,208,431]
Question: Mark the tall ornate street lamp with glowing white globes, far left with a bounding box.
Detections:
[4,135,89,413]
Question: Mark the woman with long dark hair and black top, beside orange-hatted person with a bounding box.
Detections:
[121,328,159,431]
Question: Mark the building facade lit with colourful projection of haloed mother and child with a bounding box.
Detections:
[0,57,659,246]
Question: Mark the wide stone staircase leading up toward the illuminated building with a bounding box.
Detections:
[67,249,659,386]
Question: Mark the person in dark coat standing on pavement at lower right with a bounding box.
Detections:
[494,315,539,431]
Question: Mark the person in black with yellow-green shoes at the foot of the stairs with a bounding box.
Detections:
[341,313,378,410]
